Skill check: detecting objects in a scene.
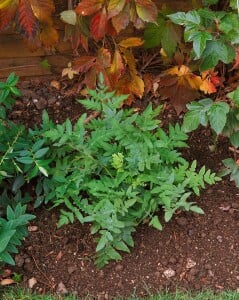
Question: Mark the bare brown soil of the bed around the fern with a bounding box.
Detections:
[2,77,239,299]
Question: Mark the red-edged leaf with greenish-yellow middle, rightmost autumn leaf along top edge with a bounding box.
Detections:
[135,0,158,22]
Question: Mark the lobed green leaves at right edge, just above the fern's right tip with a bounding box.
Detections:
[182,88,239,187]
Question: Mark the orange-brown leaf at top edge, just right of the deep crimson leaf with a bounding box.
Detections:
[29,0,55,25]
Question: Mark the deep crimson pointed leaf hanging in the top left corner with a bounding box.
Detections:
[17,0,39,39]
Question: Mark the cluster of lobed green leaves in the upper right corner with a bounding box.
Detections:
[168,7,239,71]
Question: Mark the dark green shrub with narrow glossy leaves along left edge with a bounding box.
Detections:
[0,74,49,264]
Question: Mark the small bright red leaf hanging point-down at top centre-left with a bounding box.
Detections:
[90,8,108,40]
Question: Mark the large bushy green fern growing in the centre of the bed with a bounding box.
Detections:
[33,83,219,267]
